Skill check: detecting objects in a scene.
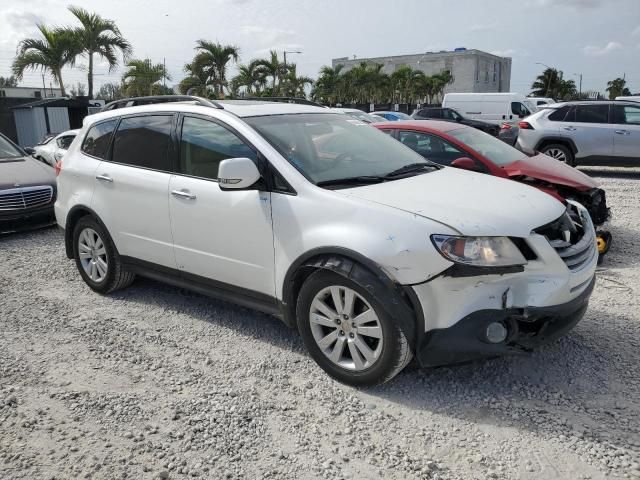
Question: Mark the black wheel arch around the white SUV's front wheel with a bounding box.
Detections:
[281,247,424,347]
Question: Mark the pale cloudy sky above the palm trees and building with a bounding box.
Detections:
[0,0,640,94]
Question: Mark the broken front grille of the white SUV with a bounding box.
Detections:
[536,203,598,272]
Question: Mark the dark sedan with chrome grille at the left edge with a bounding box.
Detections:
[0,134,56,233]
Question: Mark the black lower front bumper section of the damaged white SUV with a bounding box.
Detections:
[416,276,595,367]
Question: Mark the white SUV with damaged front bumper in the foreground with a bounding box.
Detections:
[55,96,597,385]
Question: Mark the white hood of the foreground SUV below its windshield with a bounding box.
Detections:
[336,167,565,237]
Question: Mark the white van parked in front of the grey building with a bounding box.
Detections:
[442,93,537,125]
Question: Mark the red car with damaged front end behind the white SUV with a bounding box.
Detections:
[374,120,610,226]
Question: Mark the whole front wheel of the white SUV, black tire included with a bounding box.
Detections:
[296,270,413,387]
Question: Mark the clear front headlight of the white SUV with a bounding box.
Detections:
[431,235,527,267]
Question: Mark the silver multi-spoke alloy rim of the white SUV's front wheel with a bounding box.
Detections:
[309,285,383,371]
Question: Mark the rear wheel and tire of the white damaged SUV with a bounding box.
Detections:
[73,215,135,294]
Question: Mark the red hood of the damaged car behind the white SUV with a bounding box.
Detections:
[504,153,598,190]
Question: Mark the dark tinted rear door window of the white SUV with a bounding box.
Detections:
[112,115,173,172]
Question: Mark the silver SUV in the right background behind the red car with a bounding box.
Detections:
[517,100,640,167]
